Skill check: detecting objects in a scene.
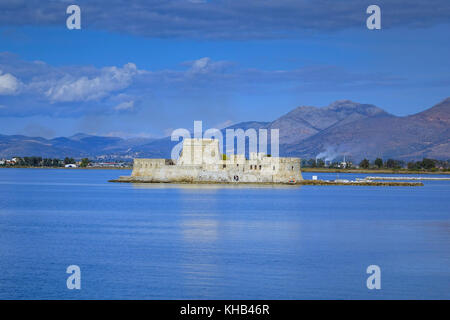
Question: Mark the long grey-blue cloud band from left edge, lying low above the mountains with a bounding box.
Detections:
[0,53,406,117]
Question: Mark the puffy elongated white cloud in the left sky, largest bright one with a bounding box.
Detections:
[45,63,139,102]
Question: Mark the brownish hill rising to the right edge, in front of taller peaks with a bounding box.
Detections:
[283,98,450,160]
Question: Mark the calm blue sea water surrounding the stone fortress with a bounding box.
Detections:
[0,169,450,299]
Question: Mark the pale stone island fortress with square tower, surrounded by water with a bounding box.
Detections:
[117,138,303,183]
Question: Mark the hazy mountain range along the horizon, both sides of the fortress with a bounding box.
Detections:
[0,98,450,161]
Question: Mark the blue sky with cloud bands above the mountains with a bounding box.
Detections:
[0,0,450,138]
